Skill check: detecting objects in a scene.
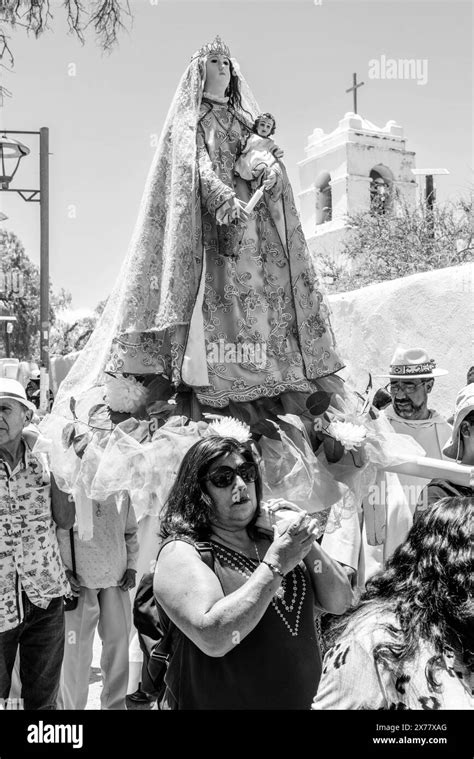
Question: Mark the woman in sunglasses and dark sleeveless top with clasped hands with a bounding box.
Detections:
[154,436,351,709]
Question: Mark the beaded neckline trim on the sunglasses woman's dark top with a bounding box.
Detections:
[212,541,306,637]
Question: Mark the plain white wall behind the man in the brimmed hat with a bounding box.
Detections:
[329,263,474,416]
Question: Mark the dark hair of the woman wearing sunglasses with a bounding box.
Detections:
[160,435,262,540]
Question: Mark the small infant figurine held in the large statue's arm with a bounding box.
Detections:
[235,113,283,196]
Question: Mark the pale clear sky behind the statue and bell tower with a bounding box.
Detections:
[0,0,474,309]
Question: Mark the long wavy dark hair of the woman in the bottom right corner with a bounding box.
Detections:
[328,497,474,691]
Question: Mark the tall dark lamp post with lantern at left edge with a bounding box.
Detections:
[0,127,49,371]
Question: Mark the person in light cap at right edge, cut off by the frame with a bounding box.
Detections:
[414,377,474,521]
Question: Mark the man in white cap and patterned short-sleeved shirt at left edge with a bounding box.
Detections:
[0,379,74,709]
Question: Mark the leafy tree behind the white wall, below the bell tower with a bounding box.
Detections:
[320,198,474,292]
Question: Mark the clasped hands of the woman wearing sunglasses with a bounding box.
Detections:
[265,512,316,575]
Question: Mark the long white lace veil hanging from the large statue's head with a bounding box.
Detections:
[53,49,259,416]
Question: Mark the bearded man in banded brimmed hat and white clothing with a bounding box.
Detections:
[322,347,451,587]
